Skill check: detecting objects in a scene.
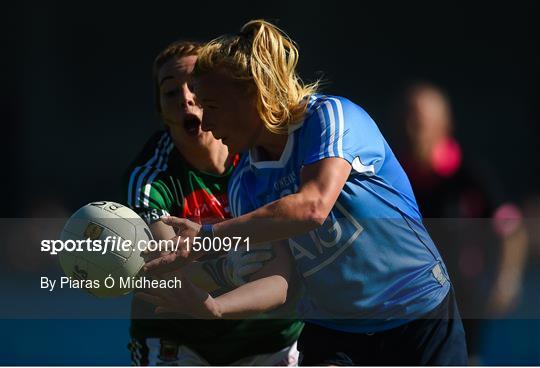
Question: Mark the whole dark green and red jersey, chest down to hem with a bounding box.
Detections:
[127,131,303,365]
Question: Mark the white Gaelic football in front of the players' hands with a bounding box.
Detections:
[58,201,152,297]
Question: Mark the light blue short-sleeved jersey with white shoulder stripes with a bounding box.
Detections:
[229,95,450,332]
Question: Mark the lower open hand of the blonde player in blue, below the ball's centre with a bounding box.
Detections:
[135,272,221,319]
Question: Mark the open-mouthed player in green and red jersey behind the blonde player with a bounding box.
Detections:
[127,42,303,365]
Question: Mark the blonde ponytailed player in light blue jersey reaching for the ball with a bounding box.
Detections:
[140,20,467,365]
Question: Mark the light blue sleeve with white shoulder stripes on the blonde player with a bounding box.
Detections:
[300,96,385,175]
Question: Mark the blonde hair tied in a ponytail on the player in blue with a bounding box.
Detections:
[194,20,319,134]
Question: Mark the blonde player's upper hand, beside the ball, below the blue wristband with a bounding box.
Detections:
[143,216,204,274]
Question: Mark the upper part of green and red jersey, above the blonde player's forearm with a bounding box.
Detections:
[128,132,237,223]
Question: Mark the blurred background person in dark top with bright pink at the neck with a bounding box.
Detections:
[396,82,527,363]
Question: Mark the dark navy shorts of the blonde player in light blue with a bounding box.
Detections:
[298,290,468,366]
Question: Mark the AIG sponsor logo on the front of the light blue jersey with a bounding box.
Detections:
[289,202,364,277]
